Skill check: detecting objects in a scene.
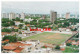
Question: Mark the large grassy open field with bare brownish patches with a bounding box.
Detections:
[23,32,71,44]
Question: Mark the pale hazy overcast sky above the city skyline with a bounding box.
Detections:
[2,1,79,14]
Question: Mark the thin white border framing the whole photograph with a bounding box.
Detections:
[0,0,80,54]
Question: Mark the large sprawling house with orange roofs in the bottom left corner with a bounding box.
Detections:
[2,42,33,53]
